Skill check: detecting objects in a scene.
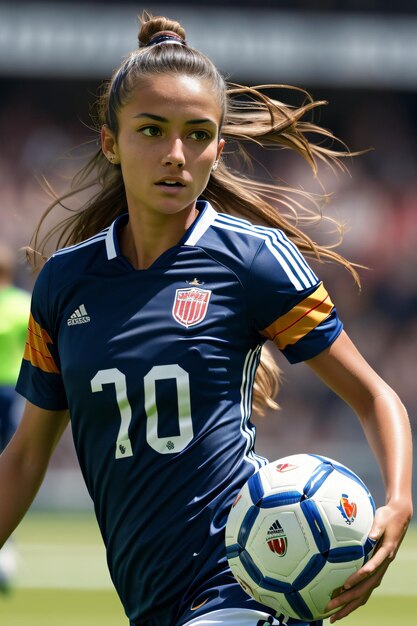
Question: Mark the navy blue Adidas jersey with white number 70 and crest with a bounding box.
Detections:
[17,202,342,623]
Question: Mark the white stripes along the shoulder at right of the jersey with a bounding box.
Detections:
[214,214,318,291]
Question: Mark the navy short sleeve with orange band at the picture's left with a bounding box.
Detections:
[16,260,68,411]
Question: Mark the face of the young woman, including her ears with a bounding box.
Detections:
[102,74,224,215]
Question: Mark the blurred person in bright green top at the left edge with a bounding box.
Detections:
[0,241,30,593]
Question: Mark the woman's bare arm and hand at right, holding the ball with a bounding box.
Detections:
[307,332,412,623]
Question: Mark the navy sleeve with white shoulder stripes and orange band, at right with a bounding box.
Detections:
[247,229,343,363]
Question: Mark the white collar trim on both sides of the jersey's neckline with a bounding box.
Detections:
[106,200,217,261]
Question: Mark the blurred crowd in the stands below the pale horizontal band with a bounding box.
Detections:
[0,74,417,502]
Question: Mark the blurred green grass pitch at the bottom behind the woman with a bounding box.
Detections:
[0,513,417,626]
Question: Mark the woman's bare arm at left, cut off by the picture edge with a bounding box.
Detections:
[0,402,69,546]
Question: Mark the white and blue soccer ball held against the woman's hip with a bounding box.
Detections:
[226,454,375,622]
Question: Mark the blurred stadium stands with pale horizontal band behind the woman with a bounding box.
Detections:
[0,0,417,623]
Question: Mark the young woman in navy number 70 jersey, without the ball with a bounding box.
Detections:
[0,15,412,626]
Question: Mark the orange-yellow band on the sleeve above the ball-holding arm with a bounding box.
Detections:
[261,283,334,350]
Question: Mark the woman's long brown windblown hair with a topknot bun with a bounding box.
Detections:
[31,12,359,414]
